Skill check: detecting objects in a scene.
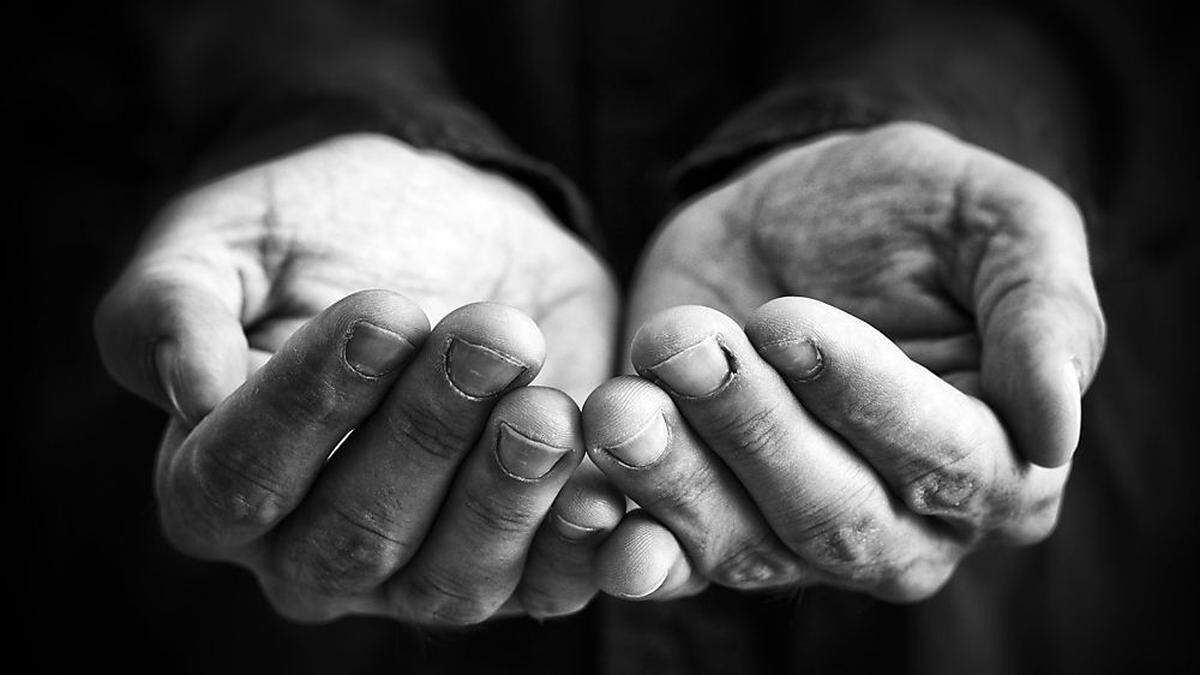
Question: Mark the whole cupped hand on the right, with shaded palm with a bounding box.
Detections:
[584,124,1104,601]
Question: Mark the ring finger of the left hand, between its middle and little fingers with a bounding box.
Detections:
[385,387,583,626]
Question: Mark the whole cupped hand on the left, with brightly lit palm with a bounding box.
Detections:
[96,136,623,625]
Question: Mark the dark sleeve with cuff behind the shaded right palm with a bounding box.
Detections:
[676,0,1106,213]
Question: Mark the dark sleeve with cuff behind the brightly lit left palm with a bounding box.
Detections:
[144,0,595,240]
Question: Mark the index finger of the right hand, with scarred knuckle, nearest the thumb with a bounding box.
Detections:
[745,298,1067,538]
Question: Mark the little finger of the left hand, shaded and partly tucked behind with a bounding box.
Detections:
[516,459,625,619]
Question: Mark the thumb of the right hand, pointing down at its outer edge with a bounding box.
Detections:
[966,165,1105,467]
